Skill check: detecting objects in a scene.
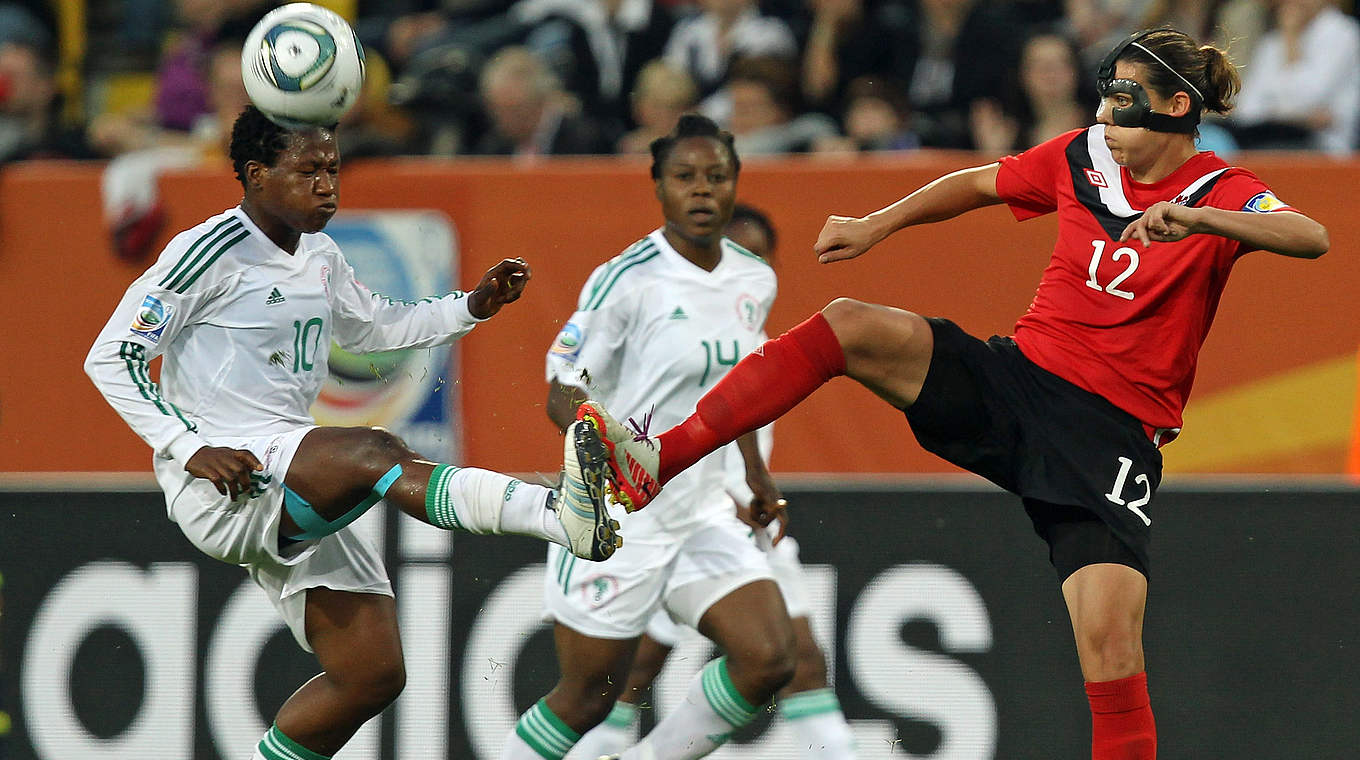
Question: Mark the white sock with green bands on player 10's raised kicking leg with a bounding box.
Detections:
[426,465,567,545]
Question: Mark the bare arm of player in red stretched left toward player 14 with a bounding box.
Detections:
[812,163,1001,264]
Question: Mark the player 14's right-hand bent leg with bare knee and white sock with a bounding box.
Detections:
[622,581,794,760]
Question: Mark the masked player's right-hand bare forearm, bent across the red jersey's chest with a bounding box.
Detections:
[1119,201,1331,258]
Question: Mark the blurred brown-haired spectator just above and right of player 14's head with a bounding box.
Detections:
[728,57,838,155]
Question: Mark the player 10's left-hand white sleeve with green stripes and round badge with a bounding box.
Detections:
[84,256,211,462]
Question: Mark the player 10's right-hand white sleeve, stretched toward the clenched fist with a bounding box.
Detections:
[330,254,483,353]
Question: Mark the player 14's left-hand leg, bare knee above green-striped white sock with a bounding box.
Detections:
[500,623,638,760]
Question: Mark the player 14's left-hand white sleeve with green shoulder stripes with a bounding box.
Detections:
[547,265,635,397]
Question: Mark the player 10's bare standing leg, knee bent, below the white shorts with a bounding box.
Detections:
[254,587,407,760]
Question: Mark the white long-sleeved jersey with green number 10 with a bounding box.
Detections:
[86,207,479,473]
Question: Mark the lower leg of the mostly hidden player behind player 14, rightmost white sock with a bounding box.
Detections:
[775,617,855,760]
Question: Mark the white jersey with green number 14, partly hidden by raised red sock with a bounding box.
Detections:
[548,230,775,534]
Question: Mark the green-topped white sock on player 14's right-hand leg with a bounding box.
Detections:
[622,657,756,760]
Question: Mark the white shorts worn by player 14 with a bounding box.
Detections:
[544,514,772,639]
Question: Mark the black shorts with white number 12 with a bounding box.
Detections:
[906,318,1161,579]
